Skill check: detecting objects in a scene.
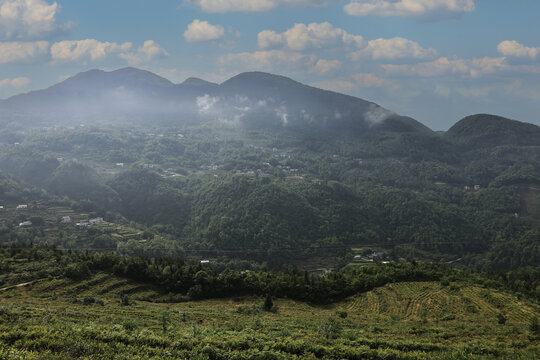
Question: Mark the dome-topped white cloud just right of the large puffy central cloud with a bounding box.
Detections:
[350,37,437,61]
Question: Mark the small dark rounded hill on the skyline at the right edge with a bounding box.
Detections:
[444,114,540,148]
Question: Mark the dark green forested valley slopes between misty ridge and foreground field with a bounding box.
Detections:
[0,115,540,270]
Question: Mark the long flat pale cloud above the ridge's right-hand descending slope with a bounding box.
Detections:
[381,57,508,78]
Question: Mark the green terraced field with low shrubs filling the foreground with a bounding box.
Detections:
[0,273,540,360]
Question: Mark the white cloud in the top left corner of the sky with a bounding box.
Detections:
[0,0,74,40]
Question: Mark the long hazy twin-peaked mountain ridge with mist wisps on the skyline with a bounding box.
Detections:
[0,68,432,136]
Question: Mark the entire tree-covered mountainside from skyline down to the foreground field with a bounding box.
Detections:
[0,69,540,269]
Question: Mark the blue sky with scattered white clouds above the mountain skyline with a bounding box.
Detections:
[0,0,540,130]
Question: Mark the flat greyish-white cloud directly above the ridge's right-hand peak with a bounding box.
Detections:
[218,50,317,71]
